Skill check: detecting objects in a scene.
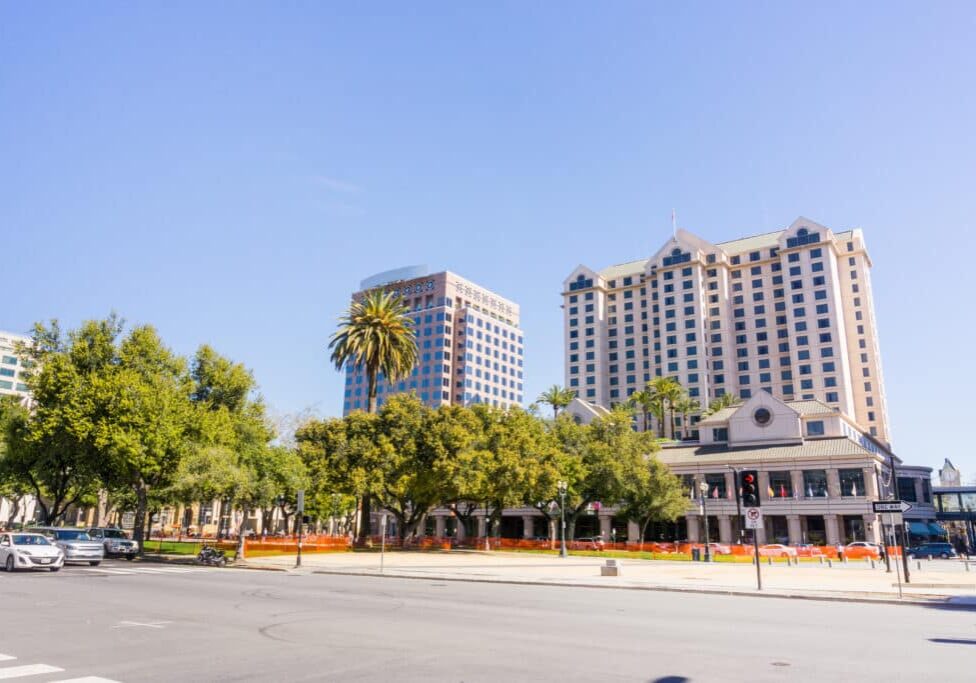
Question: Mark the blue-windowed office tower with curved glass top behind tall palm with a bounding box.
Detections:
[343,266,523,415]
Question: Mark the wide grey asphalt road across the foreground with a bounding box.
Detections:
[0,561,976,683]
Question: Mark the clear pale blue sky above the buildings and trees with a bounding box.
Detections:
[0,2,976,478]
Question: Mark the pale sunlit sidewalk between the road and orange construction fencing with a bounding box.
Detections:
[248,551,976,607]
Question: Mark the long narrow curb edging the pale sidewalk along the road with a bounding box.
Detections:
[302,569,976,611]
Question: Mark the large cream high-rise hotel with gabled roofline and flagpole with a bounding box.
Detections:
[563,218,890,442]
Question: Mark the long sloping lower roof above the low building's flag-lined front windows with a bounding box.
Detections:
[657,437,877,465]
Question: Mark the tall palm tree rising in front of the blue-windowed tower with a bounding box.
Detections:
[329,289,417,413]
